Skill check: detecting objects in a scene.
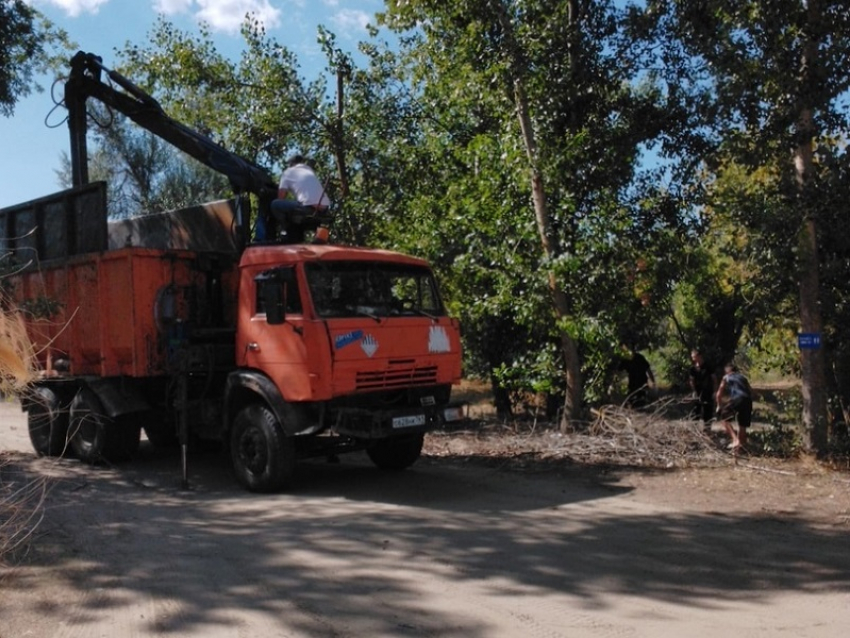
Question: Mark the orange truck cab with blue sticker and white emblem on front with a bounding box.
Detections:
[225,244,462,492]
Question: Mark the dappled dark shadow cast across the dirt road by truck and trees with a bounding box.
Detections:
[0,440,850,638]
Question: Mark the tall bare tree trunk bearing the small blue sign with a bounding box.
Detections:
[794,0,828,452]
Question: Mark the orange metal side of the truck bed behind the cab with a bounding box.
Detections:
[8,247,237,377]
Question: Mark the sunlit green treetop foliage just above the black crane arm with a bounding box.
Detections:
[113,17,324,176]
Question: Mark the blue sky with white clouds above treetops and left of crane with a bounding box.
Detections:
[0,0,384,208]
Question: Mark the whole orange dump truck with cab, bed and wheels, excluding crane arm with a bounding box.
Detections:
[0,185,463,491]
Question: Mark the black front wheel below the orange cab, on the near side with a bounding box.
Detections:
[230,403,295,492]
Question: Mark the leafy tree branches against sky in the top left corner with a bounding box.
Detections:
[0,0,71,117]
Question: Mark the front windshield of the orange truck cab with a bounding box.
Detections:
[306,261,444,318]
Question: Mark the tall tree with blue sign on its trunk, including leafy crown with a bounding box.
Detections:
[647,0,850,451]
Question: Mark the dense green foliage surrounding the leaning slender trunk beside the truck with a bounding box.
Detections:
[376,0,696,412]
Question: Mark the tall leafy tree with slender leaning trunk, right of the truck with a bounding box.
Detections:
[382,0,679,426]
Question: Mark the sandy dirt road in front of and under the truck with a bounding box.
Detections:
[0,403,850,638]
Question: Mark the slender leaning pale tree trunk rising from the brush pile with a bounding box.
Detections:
[494,0,583,430]
